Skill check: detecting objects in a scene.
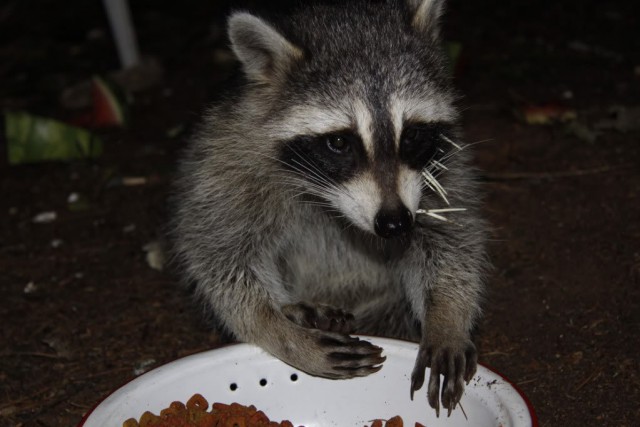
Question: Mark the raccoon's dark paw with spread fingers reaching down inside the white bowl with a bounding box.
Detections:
[411,339,478,415]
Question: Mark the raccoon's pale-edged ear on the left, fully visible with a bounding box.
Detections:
[229,12,302,83]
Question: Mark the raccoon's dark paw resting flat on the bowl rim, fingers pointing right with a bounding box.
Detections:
[307,330,386,379]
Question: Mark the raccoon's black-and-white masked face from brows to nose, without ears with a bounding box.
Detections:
[279,95,454,238]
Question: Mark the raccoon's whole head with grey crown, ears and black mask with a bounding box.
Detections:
[230,0,456,238]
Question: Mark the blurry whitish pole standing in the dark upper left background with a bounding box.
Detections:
[103,0,140,68]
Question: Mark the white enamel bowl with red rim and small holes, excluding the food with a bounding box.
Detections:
[79,337,538,427]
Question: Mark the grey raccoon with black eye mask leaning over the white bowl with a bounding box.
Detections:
[172,0,487,412]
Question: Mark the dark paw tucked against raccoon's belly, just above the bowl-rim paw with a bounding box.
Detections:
[282,302,355,334]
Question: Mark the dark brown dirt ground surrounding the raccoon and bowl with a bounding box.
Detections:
[0,0,640,427]
